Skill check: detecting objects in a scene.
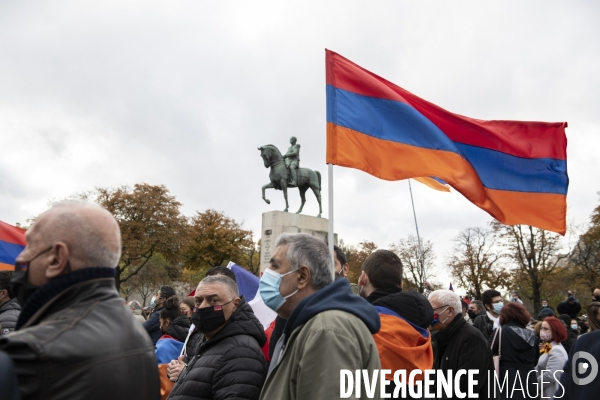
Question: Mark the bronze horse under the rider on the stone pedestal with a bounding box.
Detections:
[258,144,323,217]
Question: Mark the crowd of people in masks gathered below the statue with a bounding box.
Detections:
[0,202,600,400]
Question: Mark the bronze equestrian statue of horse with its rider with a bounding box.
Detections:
[258,136,323,217]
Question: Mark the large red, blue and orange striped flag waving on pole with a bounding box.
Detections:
[326,50,569,235]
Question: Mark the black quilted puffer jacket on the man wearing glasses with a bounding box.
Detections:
[168,299,267,400]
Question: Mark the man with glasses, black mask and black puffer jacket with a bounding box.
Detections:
[169,275,267,400]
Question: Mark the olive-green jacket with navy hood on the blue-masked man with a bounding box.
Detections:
[260,279,381,400]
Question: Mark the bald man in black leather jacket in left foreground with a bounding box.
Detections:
[0,202,160,400]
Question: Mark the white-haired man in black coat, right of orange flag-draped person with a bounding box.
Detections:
[428,290,495,399]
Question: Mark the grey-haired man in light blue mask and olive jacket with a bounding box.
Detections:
[259,233,381,400]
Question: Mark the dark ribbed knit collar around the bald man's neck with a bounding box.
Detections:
[16,267,115,330]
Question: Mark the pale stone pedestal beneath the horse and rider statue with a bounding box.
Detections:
[260,211,337,272]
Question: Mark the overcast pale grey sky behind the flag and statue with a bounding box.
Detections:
[0,0,600,284]
